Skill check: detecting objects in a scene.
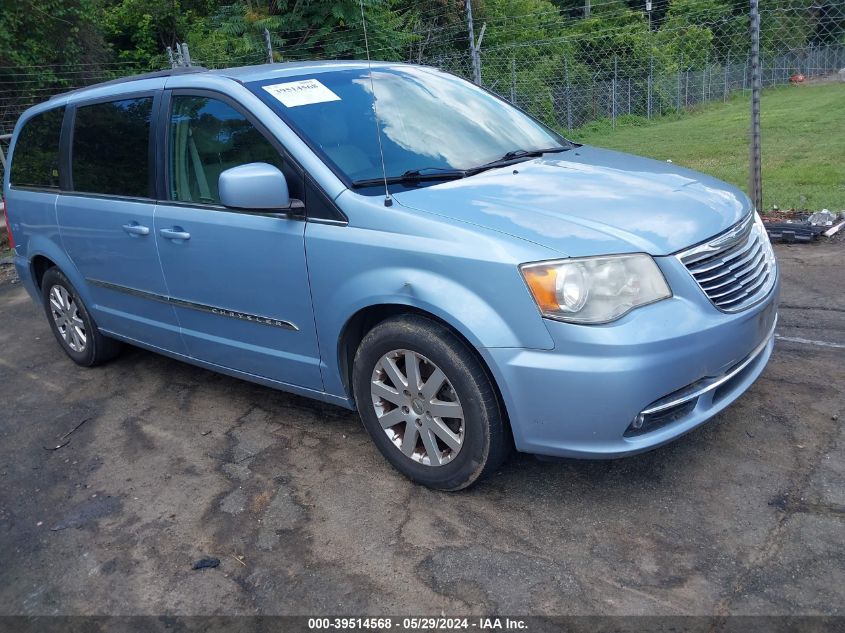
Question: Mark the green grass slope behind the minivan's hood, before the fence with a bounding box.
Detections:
[567,82,845,211]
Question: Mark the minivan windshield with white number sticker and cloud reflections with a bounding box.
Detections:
[248,65,568,182]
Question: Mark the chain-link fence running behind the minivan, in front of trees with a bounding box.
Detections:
[0,0,845,190]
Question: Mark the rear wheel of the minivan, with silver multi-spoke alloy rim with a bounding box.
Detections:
[41,267,122,367]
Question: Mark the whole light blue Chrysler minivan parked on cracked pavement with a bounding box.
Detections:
[3,62,779,490]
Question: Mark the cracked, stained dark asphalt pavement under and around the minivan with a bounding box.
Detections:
[0,243,845,615]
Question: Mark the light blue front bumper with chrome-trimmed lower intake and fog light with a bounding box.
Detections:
[486,258,780,458]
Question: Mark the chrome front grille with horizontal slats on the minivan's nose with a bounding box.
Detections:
[677,213,777,312]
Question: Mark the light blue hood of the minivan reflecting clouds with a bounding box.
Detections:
[393,146,751,257]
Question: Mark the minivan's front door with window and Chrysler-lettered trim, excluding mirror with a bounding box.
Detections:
[154,92,322,390]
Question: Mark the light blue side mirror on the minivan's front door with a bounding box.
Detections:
[217,163,302,211]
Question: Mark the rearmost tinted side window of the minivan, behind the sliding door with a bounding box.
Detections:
[9,107,65,189]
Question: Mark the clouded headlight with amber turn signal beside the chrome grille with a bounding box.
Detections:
[520,253,672,323]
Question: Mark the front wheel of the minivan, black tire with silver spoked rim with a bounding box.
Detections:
[352,315,512,490]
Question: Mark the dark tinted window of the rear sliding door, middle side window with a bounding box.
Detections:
[72,97,153,198]
